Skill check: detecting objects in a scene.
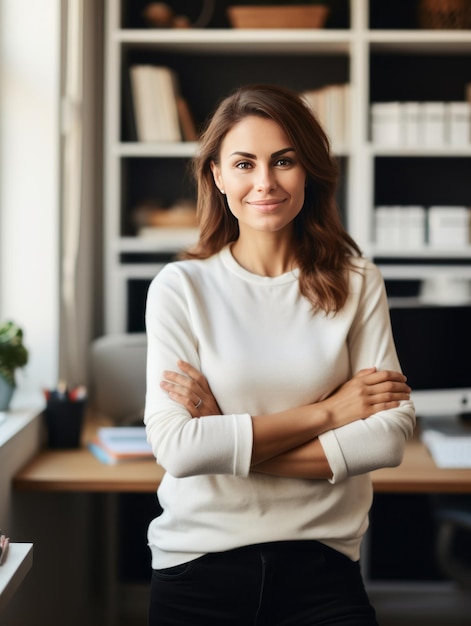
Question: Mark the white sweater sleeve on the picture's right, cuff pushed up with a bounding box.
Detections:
[319,263,415,483]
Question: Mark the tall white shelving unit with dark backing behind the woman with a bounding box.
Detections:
[104,0,471,333]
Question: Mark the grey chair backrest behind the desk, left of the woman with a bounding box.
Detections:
[90,333,147,424]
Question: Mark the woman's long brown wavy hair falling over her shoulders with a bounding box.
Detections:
[181,84,361,313]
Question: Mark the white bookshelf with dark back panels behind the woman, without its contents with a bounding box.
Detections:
[104,0,471,333]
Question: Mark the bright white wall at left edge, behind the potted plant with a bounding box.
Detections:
[0,0,60,397]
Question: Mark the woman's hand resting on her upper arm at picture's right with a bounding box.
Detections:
[324,367,411,428]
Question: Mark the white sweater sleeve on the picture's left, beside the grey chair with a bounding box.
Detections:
[144,264,253,478]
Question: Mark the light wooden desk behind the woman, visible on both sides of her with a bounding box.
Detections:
[13,428,471,493]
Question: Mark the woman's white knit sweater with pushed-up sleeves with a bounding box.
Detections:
[145,247,415,569]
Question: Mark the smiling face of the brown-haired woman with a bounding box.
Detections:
[212,116,306,235]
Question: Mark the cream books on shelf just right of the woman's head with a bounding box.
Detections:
[301,83,350,145]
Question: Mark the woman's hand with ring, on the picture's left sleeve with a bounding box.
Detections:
[160,361,221,417]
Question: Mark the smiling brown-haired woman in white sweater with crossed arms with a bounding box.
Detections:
[145,85,414,626]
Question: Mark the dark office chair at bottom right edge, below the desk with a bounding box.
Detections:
[432,495,471,589]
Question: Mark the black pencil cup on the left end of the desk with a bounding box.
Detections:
[44,399,86,448]
